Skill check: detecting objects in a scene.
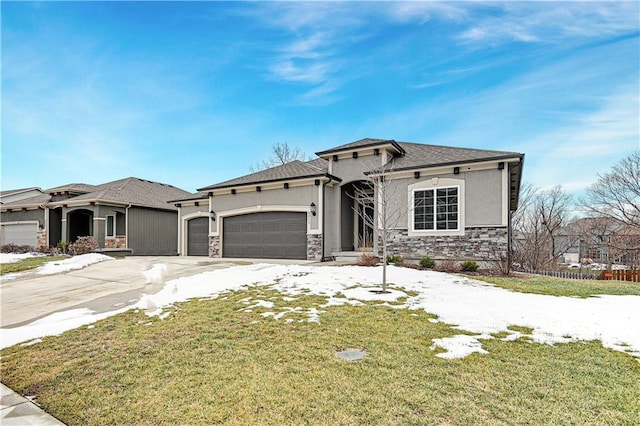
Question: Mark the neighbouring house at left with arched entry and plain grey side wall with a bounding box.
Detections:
[0,177,190,255]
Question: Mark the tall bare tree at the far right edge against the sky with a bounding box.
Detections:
[580,151,640,230]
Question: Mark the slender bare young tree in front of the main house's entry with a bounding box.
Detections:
[354,164,408,293]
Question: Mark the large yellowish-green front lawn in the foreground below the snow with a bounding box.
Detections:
[0,289,640,425]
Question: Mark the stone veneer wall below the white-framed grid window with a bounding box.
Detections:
[387,227,508,261]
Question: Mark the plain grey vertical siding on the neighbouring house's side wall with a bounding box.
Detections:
[128,207,178,256]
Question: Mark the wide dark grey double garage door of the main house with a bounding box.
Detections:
[222,212,307,259]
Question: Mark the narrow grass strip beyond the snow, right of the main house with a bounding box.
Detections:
[471,275,640,297]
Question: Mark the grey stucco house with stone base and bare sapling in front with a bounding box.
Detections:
[174,138,524,261]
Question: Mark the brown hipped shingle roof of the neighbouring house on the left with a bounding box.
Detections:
[58,177,192,210]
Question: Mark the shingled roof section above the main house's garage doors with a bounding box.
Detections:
[198,158,335,191]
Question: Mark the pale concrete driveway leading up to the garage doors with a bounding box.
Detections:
[0,256,245,328]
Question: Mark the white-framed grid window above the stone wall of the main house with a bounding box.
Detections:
[413,187,460,231]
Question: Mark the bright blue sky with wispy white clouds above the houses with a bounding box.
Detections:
[0,1,640,193]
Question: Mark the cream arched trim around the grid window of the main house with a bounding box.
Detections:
[407,178,465,237]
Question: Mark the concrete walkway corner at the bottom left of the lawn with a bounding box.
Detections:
[0,384,64,426]
